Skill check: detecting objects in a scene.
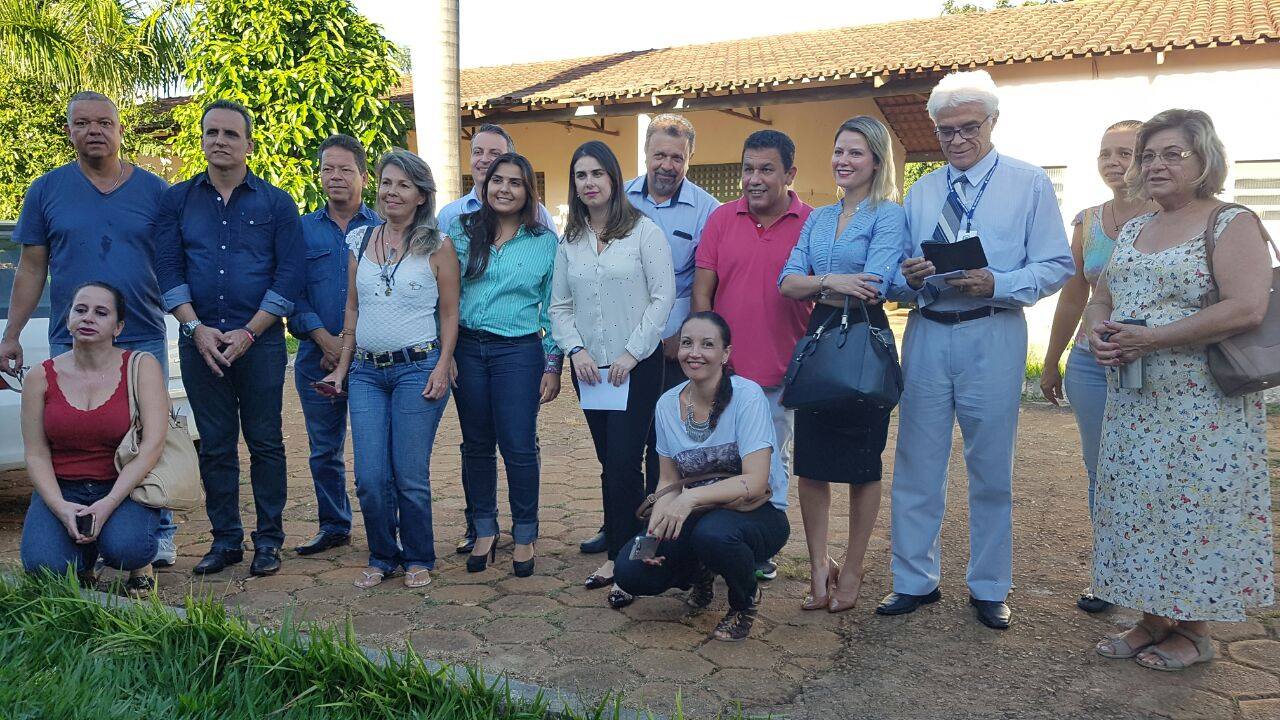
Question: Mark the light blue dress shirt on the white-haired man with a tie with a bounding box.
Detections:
[890,150,1075,313]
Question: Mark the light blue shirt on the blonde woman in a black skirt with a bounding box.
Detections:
[778,199,910,288]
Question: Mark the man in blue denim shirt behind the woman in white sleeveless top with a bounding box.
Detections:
[289,135,381,555]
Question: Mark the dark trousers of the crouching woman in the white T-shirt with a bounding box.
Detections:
[613,502,791,610]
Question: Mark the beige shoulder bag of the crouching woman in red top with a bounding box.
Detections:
[115,352,205,511]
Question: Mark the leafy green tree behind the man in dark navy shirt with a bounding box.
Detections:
[173,0,408,208]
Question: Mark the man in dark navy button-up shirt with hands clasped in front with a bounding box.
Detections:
[156,100,305,575]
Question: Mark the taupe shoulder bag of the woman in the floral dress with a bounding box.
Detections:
[1201,202,1280,396]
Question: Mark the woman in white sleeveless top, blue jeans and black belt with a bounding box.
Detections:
[325,149,460,588]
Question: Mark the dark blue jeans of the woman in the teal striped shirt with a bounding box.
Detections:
[454,329,544,544]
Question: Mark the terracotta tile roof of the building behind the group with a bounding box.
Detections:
[397,0,1280,109]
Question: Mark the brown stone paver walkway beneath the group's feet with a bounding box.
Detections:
[0,368,1280,720]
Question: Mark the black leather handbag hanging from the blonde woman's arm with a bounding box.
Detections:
[782,297,902,413]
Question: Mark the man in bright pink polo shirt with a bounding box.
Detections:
[692,129,813,473]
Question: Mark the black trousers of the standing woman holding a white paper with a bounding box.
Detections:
[573,350,663,560]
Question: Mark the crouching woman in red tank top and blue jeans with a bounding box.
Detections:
[20,282,169,594]
